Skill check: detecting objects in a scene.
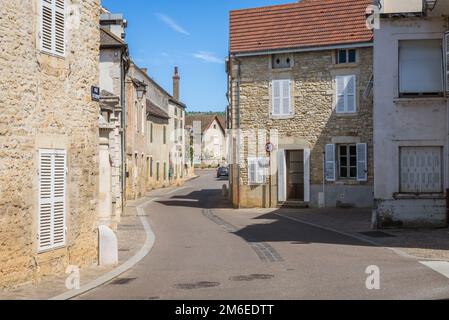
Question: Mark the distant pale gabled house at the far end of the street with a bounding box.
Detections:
[186,114,227,167]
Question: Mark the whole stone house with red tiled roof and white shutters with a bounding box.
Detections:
[227,0,374,207]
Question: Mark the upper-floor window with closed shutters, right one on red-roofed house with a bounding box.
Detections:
[335,75,357,113]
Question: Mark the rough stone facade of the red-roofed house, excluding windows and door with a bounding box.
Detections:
[230,48,373,207]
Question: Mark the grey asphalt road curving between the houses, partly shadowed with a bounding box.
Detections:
[77,171,449,300]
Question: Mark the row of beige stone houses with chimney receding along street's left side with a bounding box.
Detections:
[126,63,186,199]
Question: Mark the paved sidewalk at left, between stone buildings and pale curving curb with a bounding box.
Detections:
[0,197,151,300]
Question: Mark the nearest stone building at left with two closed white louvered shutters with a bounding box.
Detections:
[0,0,100,287]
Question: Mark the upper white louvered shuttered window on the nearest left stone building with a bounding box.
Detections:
[40,0,66,56]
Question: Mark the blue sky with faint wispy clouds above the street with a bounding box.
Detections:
[102,0,295,111]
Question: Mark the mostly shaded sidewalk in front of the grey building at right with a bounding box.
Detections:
[271,208,449,261]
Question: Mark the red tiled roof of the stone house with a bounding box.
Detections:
[230,0,373,53]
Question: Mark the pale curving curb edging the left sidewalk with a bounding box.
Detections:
[49,198,157,300]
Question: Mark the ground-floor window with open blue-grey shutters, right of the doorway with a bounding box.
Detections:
[325,143,368,182]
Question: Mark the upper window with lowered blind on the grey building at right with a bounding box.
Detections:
[399,40,443,96]
